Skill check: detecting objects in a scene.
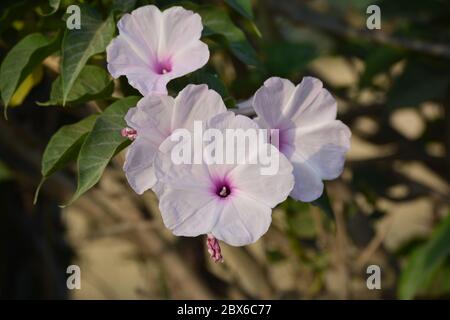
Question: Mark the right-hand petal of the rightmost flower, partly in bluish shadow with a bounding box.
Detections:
[295,120,351,180]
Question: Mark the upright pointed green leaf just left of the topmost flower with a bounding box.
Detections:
[61,6,115,105]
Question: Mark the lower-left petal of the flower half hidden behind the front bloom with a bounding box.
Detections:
[123,137,158,194]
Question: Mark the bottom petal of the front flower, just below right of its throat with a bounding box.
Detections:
[212,195,272,246]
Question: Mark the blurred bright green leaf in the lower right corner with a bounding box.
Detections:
[398,212,450,299]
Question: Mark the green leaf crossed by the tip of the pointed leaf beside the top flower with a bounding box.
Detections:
[38,65,114,106]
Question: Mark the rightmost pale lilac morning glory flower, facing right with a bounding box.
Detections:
[253,77,351,202]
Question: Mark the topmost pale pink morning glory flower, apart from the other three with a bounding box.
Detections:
[106,5,209,96]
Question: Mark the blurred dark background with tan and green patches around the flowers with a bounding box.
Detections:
[0,0,450,299]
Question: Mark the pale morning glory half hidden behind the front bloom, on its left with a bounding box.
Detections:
[122,84,226,194]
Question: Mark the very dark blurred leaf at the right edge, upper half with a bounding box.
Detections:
[386,59,450,108]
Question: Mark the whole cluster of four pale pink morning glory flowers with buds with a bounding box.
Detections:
[107,5,350,261]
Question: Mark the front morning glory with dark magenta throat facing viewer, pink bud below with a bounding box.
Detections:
[155,112,294,246]
